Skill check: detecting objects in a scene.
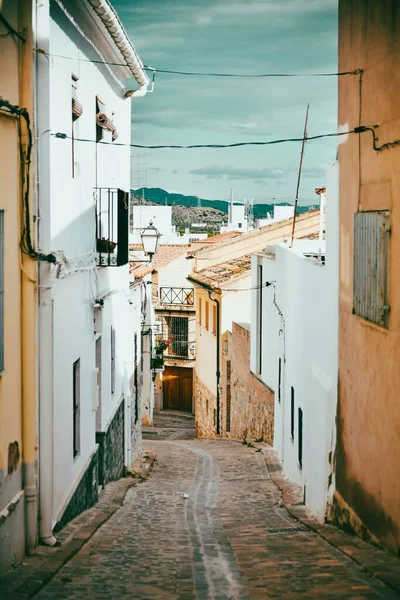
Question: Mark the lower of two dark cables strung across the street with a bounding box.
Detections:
[50,128,354,150]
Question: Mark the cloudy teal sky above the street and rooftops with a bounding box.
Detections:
[113,0,337,204]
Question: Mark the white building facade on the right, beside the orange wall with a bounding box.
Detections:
[251,166,338,521]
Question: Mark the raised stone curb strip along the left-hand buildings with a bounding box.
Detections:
[0,452,156,600]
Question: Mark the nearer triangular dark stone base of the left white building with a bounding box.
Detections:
[54,448,99,531]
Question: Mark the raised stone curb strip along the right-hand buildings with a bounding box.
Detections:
[253,442,400,594]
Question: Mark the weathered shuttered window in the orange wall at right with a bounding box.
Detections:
[353,211,390,327]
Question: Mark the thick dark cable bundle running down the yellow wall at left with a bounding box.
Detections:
[0,98,56,263]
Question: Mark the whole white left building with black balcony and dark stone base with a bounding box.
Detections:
[37,0,148,545]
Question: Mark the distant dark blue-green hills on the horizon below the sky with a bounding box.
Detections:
[132,188,308,219]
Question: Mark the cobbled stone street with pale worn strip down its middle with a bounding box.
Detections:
[36,439,399,600]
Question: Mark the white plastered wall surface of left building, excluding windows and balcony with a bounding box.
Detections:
[38,4,137,520]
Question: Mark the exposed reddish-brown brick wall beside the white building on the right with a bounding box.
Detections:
[221,323,274,444]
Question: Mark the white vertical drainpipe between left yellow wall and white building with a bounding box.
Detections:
[36,0,57,546]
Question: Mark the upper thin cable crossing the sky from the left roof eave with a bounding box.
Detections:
[36,48,359,79]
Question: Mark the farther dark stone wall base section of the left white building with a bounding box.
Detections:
[96,400,125,486]
